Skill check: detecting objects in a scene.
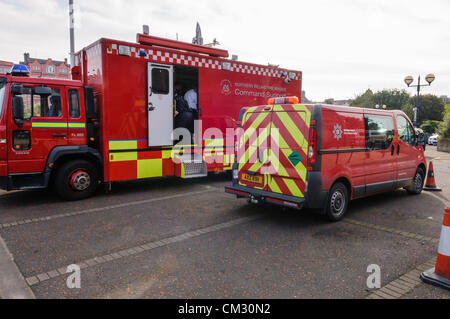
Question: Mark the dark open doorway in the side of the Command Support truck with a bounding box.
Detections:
[174,66,199,143]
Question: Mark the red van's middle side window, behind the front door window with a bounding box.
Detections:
[364,114,395,151]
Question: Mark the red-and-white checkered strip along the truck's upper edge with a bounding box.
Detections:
[106,44,300,80]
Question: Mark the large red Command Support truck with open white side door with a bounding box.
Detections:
[0,34,302,200]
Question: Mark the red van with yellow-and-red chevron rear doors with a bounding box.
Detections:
[226,98,426,221]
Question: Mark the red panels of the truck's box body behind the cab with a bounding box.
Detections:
[76,35,302,181]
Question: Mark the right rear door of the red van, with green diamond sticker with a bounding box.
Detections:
[268,104,311,197]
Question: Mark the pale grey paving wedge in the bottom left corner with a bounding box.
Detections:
[0,237,36,299]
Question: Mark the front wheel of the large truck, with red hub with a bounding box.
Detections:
[54,160,98,201]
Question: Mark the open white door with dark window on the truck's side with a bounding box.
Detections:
[147,63,173,147]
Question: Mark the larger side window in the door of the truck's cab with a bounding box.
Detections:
[18,87,61,119]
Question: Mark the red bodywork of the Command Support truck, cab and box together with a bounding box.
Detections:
[0,35,302,189]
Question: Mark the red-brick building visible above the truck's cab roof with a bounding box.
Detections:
[20,53,71,79]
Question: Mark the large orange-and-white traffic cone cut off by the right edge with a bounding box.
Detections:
[420,208,450,290]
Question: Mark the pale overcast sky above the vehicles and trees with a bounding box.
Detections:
[0,0,450,101]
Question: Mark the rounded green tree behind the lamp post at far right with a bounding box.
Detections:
[403,94,445,126]
